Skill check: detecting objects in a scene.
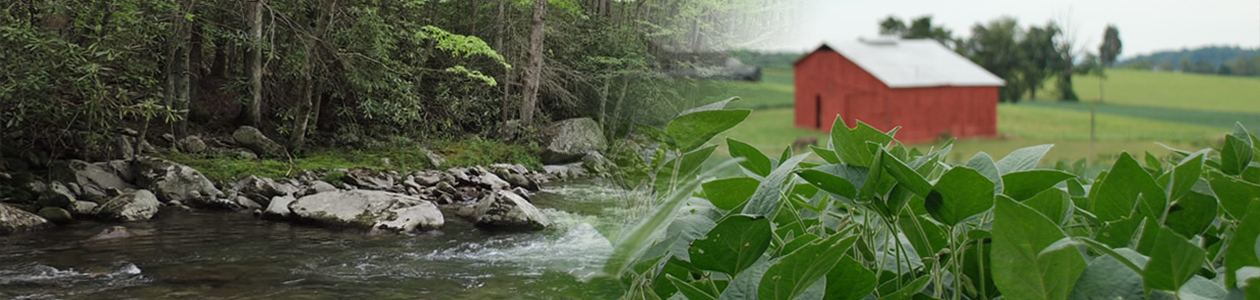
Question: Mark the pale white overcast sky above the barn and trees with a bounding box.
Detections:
[765,0,1260,58]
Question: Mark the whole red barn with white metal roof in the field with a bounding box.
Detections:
[794,39,1005,142]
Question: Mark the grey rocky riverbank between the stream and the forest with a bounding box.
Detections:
[0,120,609,234]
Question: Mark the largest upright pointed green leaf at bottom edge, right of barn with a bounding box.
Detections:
[990,195,1086,300]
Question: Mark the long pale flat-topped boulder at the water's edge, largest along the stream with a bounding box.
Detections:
[288,189,445,232]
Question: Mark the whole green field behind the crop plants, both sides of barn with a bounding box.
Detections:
[702,69,1260,165]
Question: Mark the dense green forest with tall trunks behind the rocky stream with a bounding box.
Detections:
[0,0,785,160]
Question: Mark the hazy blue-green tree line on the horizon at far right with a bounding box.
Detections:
[1120,45,1260,76]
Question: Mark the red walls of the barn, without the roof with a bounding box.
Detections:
[794,48,998,142]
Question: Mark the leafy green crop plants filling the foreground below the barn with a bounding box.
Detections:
[599,103,1260,299]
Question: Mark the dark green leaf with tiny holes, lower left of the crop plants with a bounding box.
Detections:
[688,214,771,276]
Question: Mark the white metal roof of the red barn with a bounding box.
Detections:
[823,38,1005,88]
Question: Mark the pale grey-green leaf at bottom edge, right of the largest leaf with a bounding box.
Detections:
[1068,248,1147,300]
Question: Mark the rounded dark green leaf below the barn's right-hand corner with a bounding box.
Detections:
[924,166,993,226]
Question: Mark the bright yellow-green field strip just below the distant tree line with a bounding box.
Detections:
[1063,69,1260,113]
